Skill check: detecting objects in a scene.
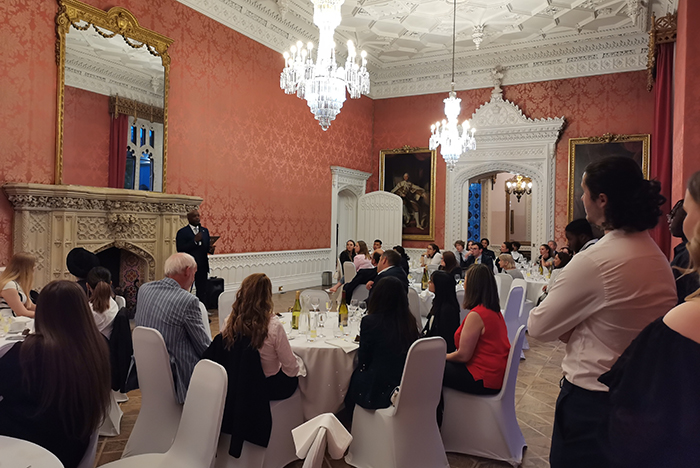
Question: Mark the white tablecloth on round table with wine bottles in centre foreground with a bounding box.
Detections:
[289,330,357,421]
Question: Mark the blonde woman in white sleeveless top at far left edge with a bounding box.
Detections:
[0,252,36,317]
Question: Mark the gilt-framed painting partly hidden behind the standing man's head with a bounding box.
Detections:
[567,133,651,222]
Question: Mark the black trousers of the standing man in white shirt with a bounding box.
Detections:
[549,379,610,468]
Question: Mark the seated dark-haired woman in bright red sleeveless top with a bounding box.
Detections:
[442,264,510,395]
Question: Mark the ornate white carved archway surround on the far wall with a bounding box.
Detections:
[445,86,564,250]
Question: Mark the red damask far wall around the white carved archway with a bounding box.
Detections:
[373,71,654,248]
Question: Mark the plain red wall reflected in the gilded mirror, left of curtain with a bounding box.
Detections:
[63,86,110,187]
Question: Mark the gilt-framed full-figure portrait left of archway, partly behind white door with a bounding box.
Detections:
[379,146,435,241]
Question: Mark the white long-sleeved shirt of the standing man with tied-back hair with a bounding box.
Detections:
[528,229,678,391]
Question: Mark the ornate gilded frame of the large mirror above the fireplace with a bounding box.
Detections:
[54,0,173,193]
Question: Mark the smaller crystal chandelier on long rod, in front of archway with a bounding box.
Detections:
[429,0,476,171]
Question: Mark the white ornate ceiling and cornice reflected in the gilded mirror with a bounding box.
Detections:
[66,27,164,107]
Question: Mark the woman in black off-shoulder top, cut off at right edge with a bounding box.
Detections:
[598,172,700,468]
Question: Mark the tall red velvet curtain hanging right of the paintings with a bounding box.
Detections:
[651,42,674,256]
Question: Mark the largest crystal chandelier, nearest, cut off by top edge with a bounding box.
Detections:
[280,0,369,131]
